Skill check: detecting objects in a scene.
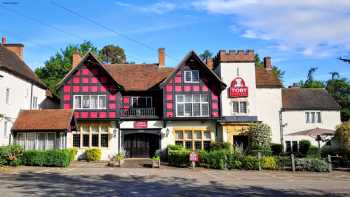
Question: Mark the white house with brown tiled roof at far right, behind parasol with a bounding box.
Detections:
[281,87,341,152]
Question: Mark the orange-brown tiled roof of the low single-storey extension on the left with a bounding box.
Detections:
[12,109,73,131]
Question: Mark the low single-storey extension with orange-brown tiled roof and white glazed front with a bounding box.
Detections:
[11,109,76,150]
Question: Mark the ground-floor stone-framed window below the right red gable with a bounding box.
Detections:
[175,129,211,150]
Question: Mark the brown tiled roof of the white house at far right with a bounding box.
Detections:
[282,88,340,110]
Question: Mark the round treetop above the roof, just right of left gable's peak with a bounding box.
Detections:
[100,44,126,64]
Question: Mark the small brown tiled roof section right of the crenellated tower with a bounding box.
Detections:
[255,68,283,88]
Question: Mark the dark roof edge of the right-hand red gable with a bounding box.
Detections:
[160,51,226,89]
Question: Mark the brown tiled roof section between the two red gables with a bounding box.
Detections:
[104,64,174,91]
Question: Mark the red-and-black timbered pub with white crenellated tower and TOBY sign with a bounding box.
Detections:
[11,48,340,160]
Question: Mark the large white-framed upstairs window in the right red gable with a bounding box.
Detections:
[176,94,209,117]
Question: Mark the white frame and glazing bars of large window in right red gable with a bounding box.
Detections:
[175,94,210,117]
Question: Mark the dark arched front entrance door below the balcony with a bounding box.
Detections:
[124,133,159,158]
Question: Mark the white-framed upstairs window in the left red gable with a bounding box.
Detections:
[74,95,107,109]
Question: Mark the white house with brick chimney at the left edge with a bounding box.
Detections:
[0,37,47,146]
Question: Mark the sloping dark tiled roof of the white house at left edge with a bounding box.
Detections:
[0,44,47,89]
